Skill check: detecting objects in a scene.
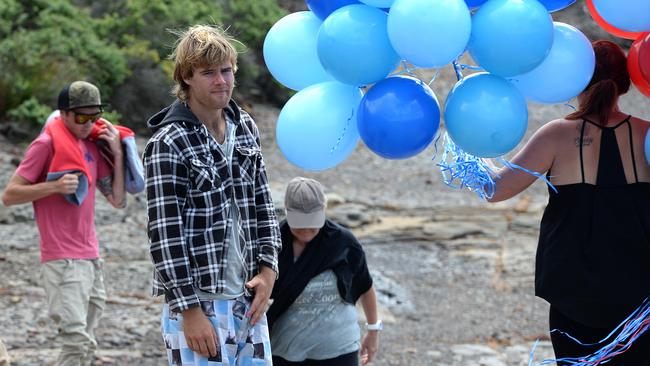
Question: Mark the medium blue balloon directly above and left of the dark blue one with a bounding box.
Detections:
[317,4,400,86]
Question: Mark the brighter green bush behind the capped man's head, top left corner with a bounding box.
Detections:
[0,0,128,123]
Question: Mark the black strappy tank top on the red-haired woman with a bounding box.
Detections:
[535,116,650,328]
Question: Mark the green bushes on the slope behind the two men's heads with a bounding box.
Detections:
[0,0,286,134]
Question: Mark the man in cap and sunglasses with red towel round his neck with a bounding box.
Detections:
[2,81,126,366]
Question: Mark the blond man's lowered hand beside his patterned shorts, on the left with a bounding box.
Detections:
[183,307,219,357]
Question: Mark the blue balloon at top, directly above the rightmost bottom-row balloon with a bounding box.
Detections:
[468,0,553,77]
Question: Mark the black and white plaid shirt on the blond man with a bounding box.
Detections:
[143,101,282,312]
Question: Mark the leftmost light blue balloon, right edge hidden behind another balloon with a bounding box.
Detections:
[263,11,333,90]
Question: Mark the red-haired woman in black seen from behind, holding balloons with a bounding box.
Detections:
[490,41,650,365]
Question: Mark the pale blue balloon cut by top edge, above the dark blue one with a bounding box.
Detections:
[388,0,472,67]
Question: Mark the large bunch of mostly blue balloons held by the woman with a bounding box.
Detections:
[264,0,650,170]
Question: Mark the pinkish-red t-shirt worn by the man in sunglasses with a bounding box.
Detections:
[16,133,111,262]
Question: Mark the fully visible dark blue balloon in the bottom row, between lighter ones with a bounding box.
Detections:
[357,76,440,159]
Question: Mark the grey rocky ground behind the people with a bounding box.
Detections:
[0,84,650,366]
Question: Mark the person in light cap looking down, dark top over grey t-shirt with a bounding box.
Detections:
[267,177,382,366]
